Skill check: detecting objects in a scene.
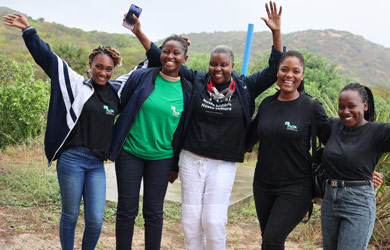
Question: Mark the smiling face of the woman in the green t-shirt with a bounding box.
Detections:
[160,40,188,77]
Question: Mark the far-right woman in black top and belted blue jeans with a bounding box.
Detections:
[321,83,390,250]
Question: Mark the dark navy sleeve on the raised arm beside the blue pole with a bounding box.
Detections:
[244,46,286,99]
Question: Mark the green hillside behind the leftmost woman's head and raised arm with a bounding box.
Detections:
[0,7,145,77]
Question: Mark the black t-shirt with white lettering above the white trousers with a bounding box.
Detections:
[183,83,246,162]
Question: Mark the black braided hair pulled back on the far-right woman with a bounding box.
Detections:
[340,82,376,122]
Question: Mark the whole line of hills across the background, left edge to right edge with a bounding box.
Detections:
[0,7,390,86]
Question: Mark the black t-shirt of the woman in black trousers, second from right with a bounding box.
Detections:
[255,94,329,186]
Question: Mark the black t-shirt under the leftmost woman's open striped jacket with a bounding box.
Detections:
[62,84,118,160]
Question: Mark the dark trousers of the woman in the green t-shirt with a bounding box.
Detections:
[115,149,173,250]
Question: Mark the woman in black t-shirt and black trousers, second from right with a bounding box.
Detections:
[253,50,329,250]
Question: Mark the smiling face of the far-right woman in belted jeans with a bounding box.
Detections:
[337,90,368,129]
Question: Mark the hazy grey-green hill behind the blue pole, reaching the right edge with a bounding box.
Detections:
[179,30,390,86]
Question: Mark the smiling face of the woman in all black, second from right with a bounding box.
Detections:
[276,56,303,96]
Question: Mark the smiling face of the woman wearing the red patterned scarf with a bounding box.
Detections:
[209,53,234,84]
